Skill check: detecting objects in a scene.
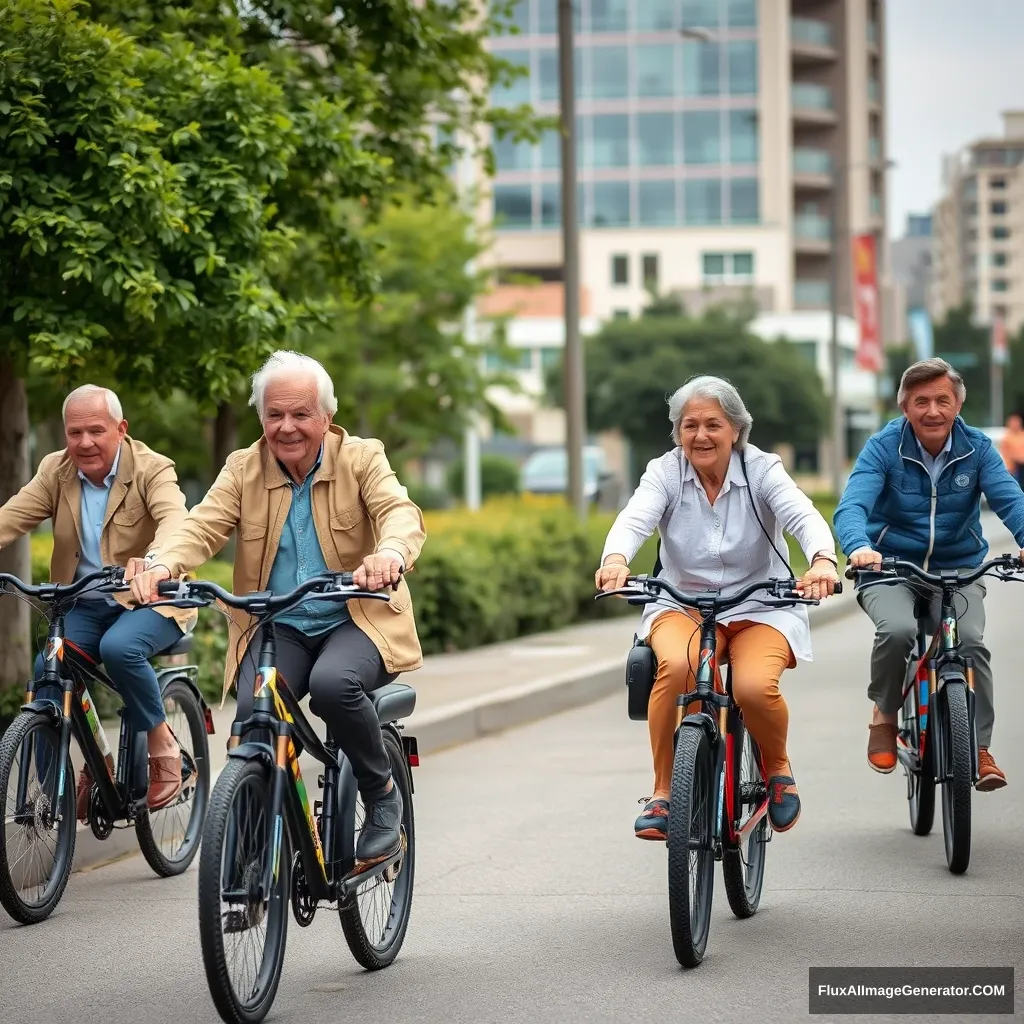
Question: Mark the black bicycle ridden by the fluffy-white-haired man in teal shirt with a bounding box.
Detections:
[154,572,419,1024]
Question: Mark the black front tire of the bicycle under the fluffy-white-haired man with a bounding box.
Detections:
[199,758,291,1024]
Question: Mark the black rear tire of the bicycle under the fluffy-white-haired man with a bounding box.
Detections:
[338,729,416,971]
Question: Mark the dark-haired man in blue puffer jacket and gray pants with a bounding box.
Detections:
[833,359,1024,791]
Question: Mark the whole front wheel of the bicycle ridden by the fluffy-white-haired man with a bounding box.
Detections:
[199,758,291,1024]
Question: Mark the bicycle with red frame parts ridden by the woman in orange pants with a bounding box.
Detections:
[597,574,843,968]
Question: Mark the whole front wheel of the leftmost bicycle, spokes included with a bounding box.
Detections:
[0,712,77,925]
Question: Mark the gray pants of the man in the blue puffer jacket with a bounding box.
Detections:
[857,580,995,746]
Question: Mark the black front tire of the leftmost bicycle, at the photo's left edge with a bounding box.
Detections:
[0,711,78,925]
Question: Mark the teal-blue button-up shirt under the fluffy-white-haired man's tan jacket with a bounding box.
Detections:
[267,444,349,636]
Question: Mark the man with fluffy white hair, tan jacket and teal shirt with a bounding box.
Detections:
[132,352,425,862]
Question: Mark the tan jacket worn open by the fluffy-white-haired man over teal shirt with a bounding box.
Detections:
[154,425,426,696]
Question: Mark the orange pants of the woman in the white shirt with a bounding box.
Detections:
[647,611,796,800]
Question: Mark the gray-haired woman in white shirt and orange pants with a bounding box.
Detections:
[595,377,839,840]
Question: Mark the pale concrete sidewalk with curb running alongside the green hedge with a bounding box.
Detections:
[66,513,1015,870]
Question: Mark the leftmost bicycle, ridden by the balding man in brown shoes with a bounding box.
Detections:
[0,566,213,925]
